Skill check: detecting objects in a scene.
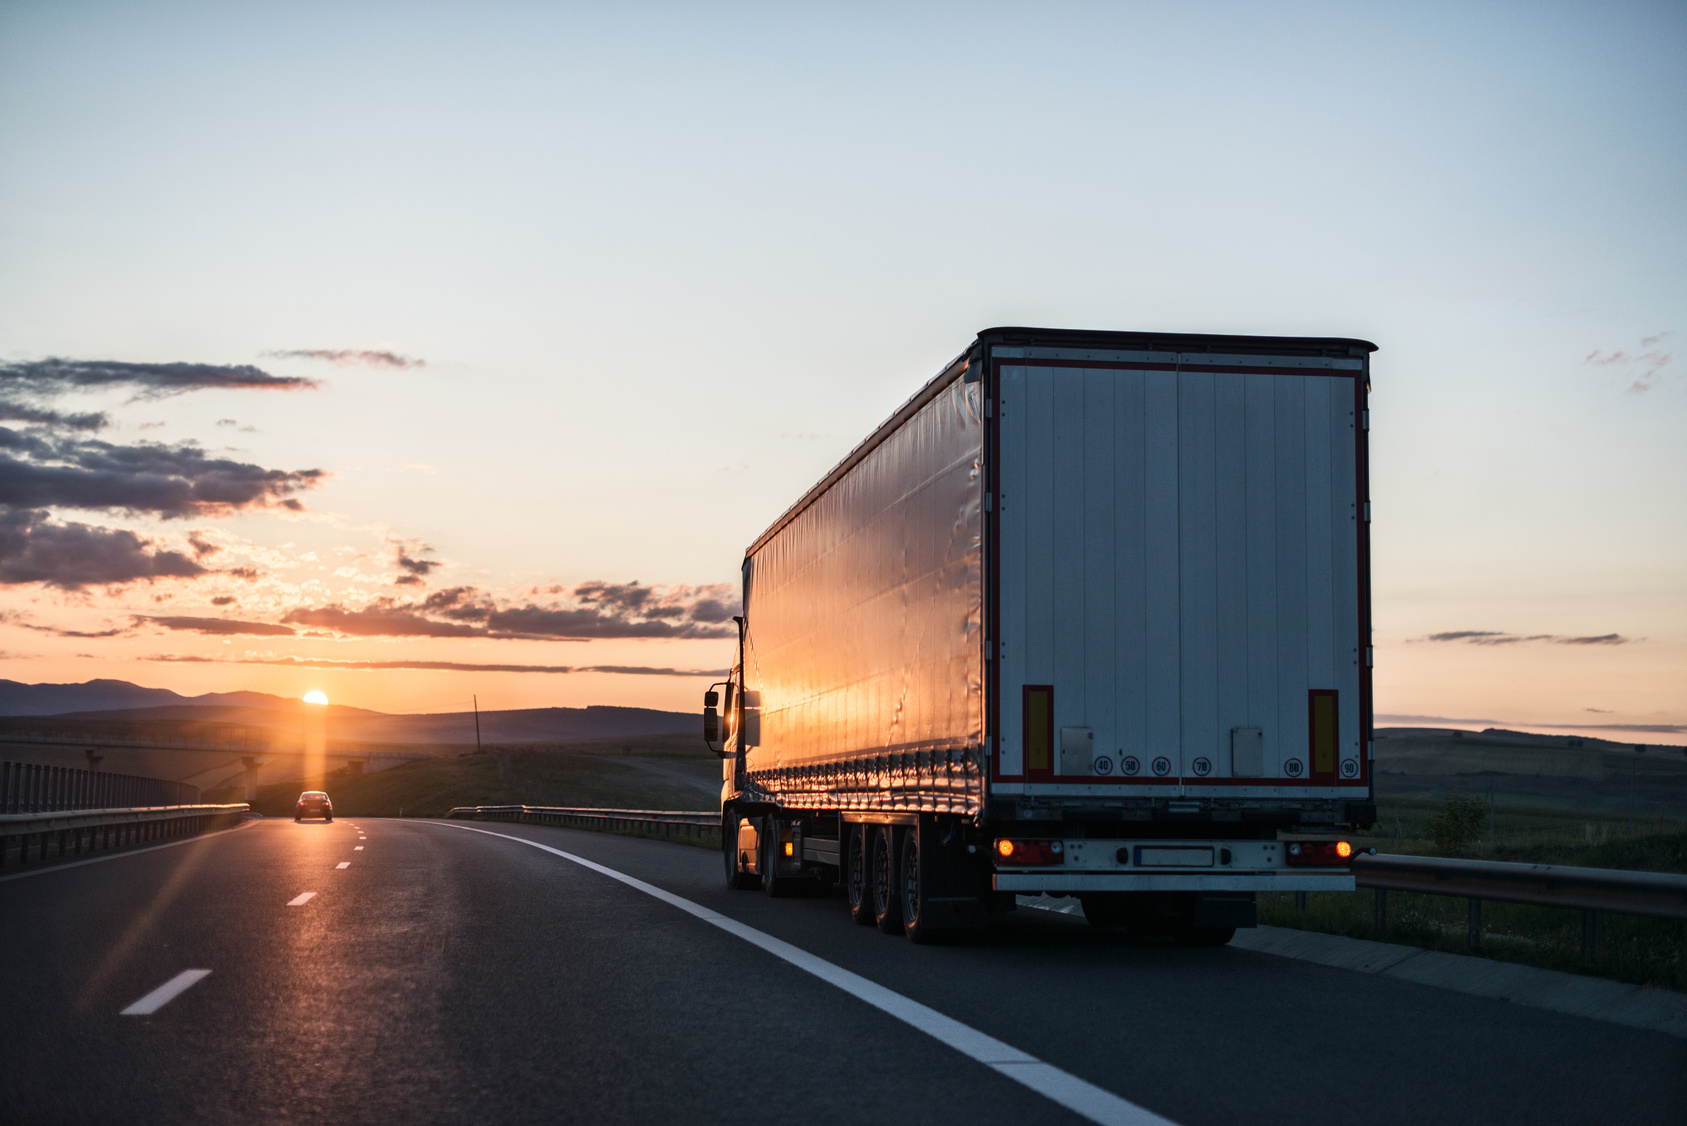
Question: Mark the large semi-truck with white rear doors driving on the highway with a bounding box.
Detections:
[702,328,1377,945]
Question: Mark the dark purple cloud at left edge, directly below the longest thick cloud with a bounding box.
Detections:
[0,508,211,591]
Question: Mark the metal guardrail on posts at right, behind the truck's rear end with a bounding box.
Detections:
[1353,856,1687,961]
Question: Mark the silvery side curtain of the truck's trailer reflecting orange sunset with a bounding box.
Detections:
[746,380,984,771]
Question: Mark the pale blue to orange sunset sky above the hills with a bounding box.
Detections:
[0,0,1687,743]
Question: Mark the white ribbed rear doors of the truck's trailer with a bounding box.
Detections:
[992,349,1368,797]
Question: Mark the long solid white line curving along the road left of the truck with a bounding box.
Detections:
[423,820,1176,1126]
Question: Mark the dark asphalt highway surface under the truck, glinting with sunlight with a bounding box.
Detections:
[0,819,1687,1126]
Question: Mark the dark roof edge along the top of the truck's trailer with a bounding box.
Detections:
[744,326,1377,559]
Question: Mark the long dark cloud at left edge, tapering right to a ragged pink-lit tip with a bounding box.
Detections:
[0,427,327,518]
